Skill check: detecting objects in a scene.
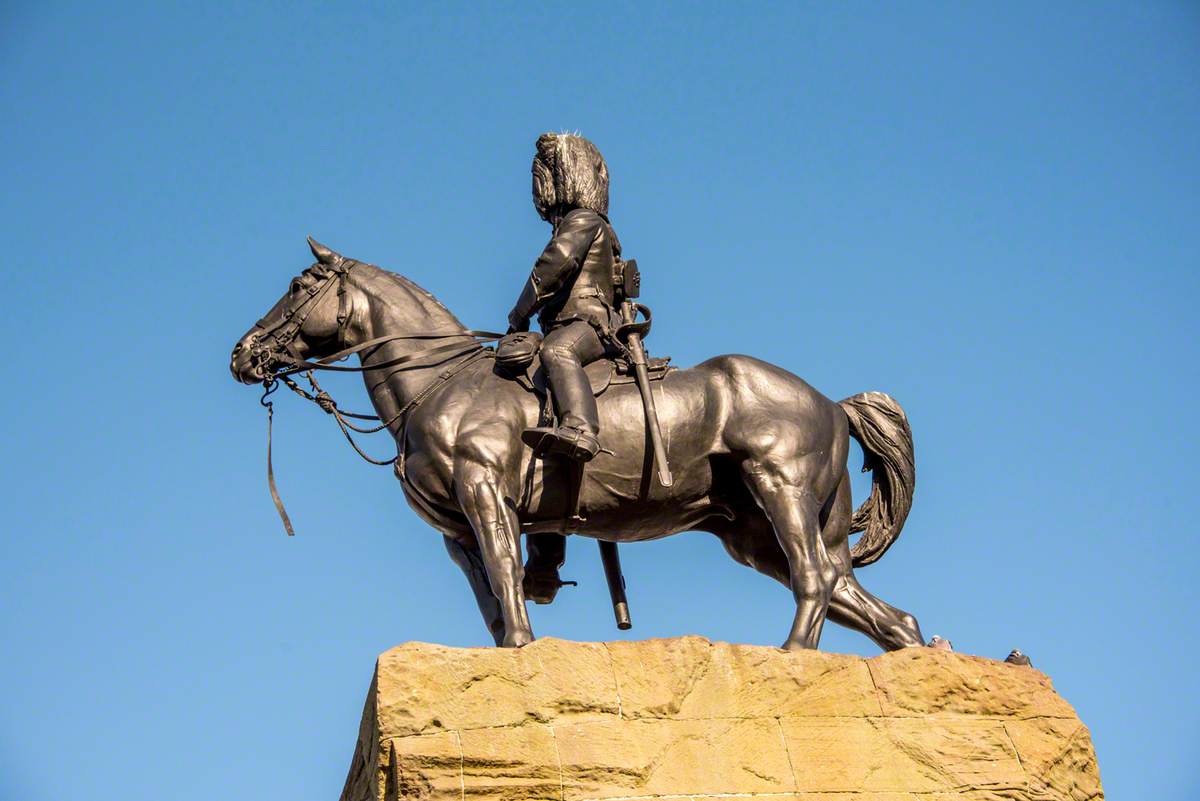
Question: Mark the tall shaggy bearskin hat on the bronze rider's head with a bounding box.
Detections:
[533,133,608,222]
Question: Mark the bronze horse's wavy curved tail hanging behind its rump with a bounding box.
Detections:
[838,392,917,567]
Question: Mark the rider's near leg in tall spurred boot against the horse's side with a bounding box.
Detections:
[532,320,605,460]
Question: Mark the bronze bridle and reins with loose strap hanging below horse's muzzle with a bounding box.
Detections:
[248,255,504,536]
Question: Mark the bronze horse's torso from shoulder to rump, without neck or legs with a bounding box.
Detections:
[409,355,846,536]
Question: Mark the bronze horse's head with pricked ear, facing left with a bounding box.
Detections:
[229,237,353,384]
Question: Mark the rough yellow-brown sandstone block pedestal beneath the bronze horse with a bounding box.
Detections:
[342,637,1104,801]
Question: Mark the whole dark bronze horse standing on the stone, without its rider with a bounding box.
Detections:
[230,243,924,650]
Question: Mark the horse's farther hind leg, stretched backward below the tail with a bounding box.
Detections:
[821,475,925,651]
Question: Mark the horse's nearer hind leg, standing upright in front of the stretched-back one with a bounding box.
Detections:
[742,457,836,650]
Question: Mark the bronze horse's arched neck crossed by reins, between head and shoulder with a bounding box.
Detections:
[347,265,474,422]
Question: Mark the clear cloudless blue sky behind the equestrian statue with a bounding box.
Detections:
[0,0,1200,801]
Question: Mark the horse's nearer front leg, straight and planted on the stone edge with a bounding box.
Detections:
[455,459,533,648]
